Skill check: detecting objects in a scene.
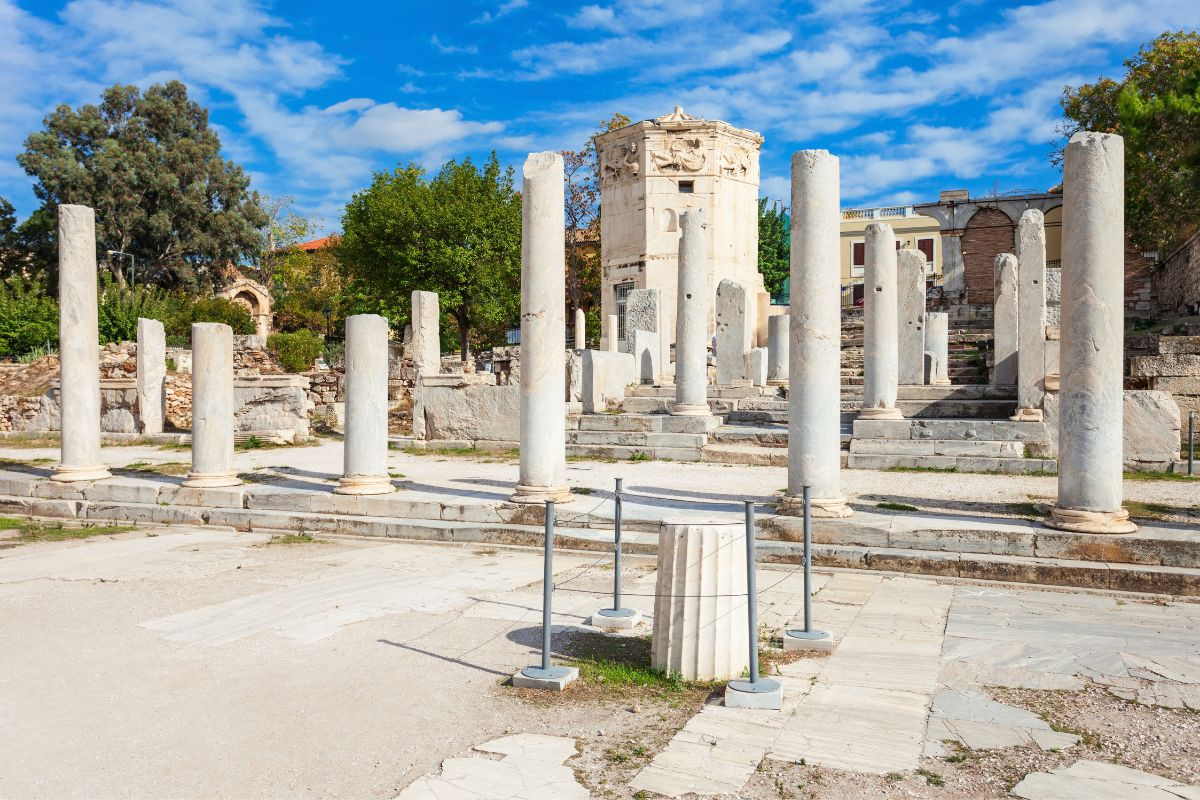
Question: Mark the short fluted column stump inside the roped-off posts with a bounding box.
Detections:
[650,521,749,680]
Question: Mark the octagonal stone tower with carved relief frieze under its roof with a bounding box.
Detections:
[595,106,764,349]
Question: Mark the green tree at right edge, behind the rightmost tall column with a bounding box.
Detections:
[1055,31,1200,252]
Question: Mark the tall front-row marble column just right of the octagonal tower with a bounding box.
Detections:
[780,150,852,517]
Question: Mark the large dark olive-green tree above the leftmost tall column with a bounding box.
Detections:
[17,80,266,291]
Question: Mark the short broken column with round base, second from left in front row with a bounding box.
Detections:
[184,323,241,488]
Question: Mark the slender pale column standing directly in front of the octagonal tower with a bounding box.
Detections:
[671,209,709,416]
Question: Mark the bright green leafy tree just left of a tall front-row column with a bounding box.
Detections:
[337,151,521,361]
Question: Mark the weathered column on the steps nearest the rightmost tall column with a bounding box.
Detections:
[1013,209,1046,422]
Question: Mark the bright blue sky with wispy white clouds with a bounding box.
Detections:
[0,0,1200,230]
